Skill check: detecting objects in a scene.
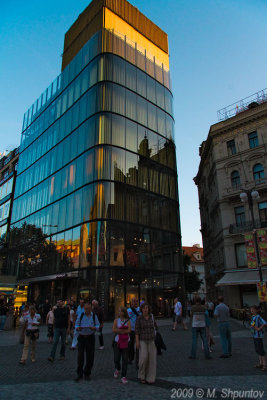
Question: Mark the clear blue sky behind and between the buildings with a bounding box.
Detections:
[0,0,267,246]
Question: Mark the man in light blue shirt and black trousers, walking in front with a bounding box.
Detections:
[75,303,99,382]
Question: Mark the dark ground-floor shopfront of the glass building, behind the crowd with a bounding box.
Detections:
[20,268,183,319]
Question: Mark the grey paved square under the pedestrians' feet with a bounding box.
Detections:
[0,320,267,400]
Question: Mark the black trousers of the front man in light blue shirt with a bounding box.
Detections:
[77,334,95,378]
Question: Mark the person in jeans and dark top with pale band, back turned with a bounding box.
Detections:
[189,297,211,360]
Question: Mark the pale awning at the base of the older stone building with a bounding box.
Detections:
[216,269,267,286]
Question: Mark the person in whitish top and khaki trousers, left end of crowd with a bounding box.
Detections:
[19,306,41,365]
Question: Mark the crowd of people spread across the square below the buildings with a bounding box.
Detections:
[0,297,267,384]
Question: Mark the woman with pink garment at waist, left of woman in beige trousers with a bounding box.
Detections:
[112,307,131,384]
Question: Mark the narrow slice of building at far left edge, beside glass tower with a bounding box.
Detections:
[0,148,19,295]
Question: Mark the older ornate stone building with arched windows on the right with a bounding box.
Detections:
[194,90,267,307]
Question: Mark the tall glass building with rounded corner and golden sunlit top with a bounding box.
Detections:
[10,0,183,316]
